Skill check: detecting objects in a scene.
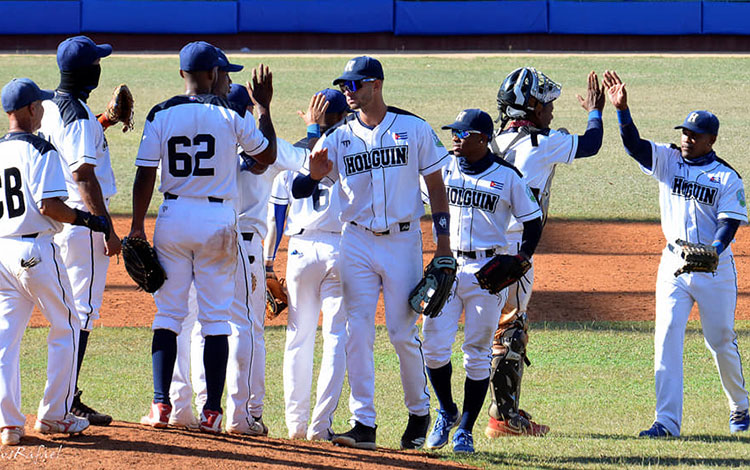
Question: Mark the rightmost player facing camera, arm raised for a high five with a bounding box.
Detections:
[604,71,750,438]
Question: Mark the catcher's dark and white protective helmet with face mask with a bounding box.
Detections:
[497,67,561,123]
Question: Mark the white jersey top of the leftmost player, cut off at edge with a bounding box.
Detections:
[0,132,68,237]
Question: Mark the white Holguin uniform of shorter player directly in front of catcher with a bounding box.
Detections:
[422,155,542,380]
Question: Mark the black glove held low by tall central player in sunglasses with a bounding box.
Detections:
[409,256,458,318]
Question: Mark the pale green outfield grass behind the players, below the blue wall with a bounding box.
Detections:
[0,53,750,220]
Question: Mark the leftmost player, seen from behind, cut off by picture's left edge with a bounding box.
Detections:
[0,78,110,445]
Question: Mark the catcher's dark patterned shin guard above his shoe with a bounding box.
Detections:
[489,309,529,420]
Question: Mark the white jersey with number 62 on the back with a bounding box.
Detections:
[136,95,268,199]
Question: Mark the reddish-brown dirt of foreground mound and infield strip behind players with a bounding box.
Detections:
[14,217,750,470]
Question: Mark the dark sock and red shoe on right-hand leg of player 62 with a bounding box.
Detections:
[200,335,229,434]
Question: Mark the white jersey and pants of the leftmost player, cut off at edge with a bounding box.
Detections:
[0,132,80,428]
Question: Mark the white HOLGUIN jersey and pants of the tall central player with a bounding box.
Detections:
[306,107,447,427]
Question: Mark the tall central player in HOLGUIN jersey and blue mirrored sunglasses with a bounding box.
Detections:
[292,56,451,449]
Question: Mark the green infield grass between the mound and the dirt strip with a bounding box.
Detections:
[16,321,750,470]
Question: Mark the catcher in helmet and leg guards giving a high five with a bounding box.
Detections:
[484,67,605,438]
